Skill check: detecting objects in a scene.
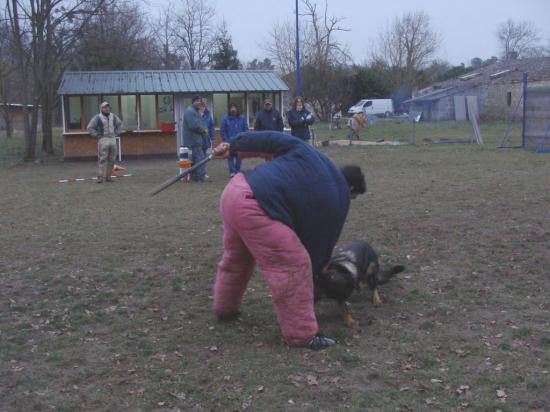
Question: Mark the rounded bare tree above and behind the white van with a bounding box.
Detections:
[372,11,441,90]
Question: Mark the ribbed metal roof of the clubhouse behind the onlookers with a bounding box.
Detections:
[57,70,288,95]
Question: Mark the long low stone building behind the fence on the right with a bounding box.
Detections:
[404,57,550,121]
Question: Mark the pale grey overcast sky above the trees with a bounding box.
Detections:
[143,0,550,65]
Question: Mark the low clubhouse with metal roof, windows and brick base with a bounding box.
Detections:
[58,70,288,159]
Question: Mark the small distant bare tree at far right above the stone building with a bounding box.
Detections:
[496,19,543,59]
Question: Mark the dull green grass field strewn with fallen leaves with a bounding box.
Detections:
[0,120,550,412]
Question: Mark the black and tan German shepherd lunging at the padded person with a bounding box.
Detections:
[315,240,405,329]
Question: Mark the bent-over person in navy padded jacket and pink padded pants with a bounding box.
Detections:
[213,131,366,349]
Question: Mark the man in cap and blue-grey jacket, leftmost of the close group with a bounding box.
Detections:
[183,95,208,182]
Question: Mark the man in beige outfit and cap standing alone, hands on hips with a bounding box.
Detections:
[88,102,122,183]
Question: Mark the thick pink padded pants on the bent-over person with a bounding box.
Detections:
[214,173,318,346]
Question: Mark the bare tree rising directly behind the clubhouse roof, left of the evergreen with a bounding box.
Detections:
[172,0,216,69]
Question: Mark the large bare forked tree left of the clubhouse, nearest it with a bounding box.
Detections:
[6,0,108,160]
